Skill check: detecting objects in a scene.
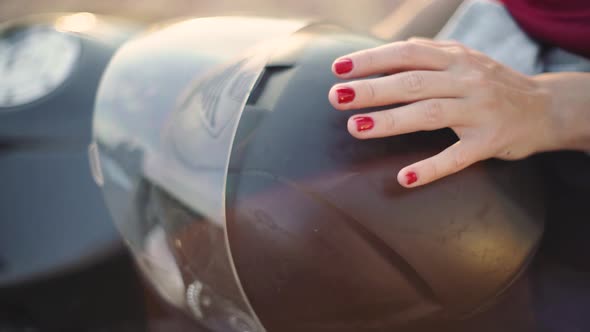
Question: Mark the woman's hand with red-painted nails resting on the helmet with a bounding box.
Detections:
[329,39,556,187]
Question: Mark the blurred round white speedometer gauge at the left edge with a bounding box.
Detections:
[0,25,81,108]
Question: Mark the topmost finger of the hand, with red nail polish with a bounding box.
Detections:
[332,42,451,79]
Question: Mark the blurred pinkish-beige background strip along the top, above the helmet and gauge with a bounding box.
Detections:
[0,0,402,28]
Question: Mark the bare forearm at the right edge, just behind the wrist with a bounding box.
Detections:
[535,73,590,151]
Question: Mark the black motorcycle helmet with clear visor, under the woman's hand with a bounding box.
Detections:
[91,17,543,332]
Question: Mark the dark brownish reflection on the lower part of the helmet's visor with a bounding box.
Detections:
[144,187,256,331]
